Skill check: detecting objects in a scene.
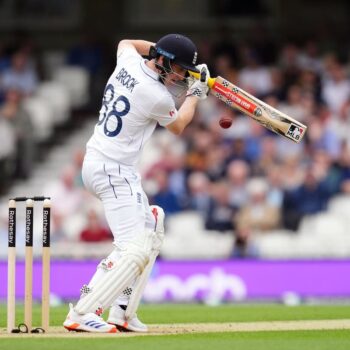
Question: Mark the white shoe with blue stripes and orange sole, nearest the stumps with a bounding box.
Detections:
[63,304,118,333]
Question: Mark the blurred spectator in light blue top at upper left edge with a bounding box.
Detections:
[0,50,38,95]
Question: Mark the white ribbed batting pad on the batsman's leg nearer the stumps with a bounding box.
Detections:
[74,231,155,314]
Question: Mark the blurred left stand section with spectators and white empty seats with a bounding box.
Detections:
[0,31,105,193]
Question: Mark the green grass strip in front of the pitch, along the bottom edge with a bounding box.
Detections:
[0,330,350,350]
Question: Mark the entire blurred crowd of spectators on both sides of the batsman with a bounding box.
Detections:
[0,29,350,256]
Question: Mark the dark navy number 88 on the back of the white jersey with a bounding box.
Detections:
[97,84,130,137]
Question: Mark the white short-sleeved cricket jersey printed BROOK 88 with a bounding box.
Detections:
[87,49,177,166]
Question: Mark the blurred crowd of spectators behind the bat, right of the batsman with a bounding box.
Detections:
[146,29,350,256]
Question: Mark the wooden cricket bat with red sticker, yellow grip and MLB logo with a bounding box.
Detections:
[189,72,307,143]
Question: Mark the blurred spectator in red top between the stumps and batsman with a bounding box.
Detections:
[80,209,113,242]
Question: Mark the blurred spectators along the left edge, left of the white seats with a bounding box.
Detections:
[0,38,39,191]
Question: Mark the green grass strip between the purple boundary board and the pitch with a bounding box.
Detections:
[0,304,350,327]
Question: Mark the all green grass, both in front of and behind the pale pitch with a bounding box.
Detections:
[0,304,350,350]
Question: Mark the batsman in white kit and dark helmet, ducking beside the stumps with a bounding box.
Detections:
[63,34,209,333]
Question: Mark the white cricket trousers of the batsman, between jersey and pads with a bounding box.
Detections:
[82,154,155,250]
